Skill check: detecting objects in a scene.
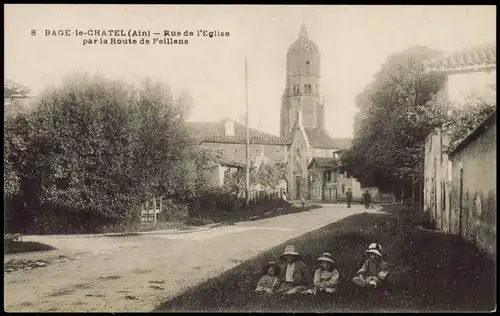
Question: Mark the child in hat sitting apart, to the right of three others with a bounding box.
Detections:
[352,243,389,288]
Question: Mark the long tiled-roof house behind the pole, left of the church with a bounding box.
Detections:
[186,119,289,187]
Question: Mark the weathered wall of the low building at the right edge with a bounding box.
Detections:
[450,122,497,255]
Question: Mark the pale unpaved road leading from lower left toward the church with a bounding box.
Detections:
[4,204,378,312]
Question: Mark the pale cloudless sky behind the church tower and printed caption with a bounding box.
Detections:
[4,4,496,137]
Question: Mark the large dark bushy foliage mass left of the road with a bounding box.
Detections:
[4,75,198,233]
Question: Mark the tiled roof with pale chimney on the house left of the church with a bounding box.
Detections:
[186,120,290,145]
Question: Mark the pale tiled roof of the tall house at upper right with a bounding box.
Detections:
[424,43,497,72]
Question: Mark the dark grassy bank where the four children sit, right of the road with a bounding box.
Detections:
[155,206,496,311]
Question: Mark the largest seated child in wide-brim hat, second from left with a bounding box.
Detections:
[277,245,311,294]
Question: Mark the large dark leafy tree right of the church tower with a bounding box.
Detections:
[341,47,442,188]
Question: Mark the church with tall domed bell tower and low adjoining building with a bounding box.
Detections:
[280,24,362,200]
